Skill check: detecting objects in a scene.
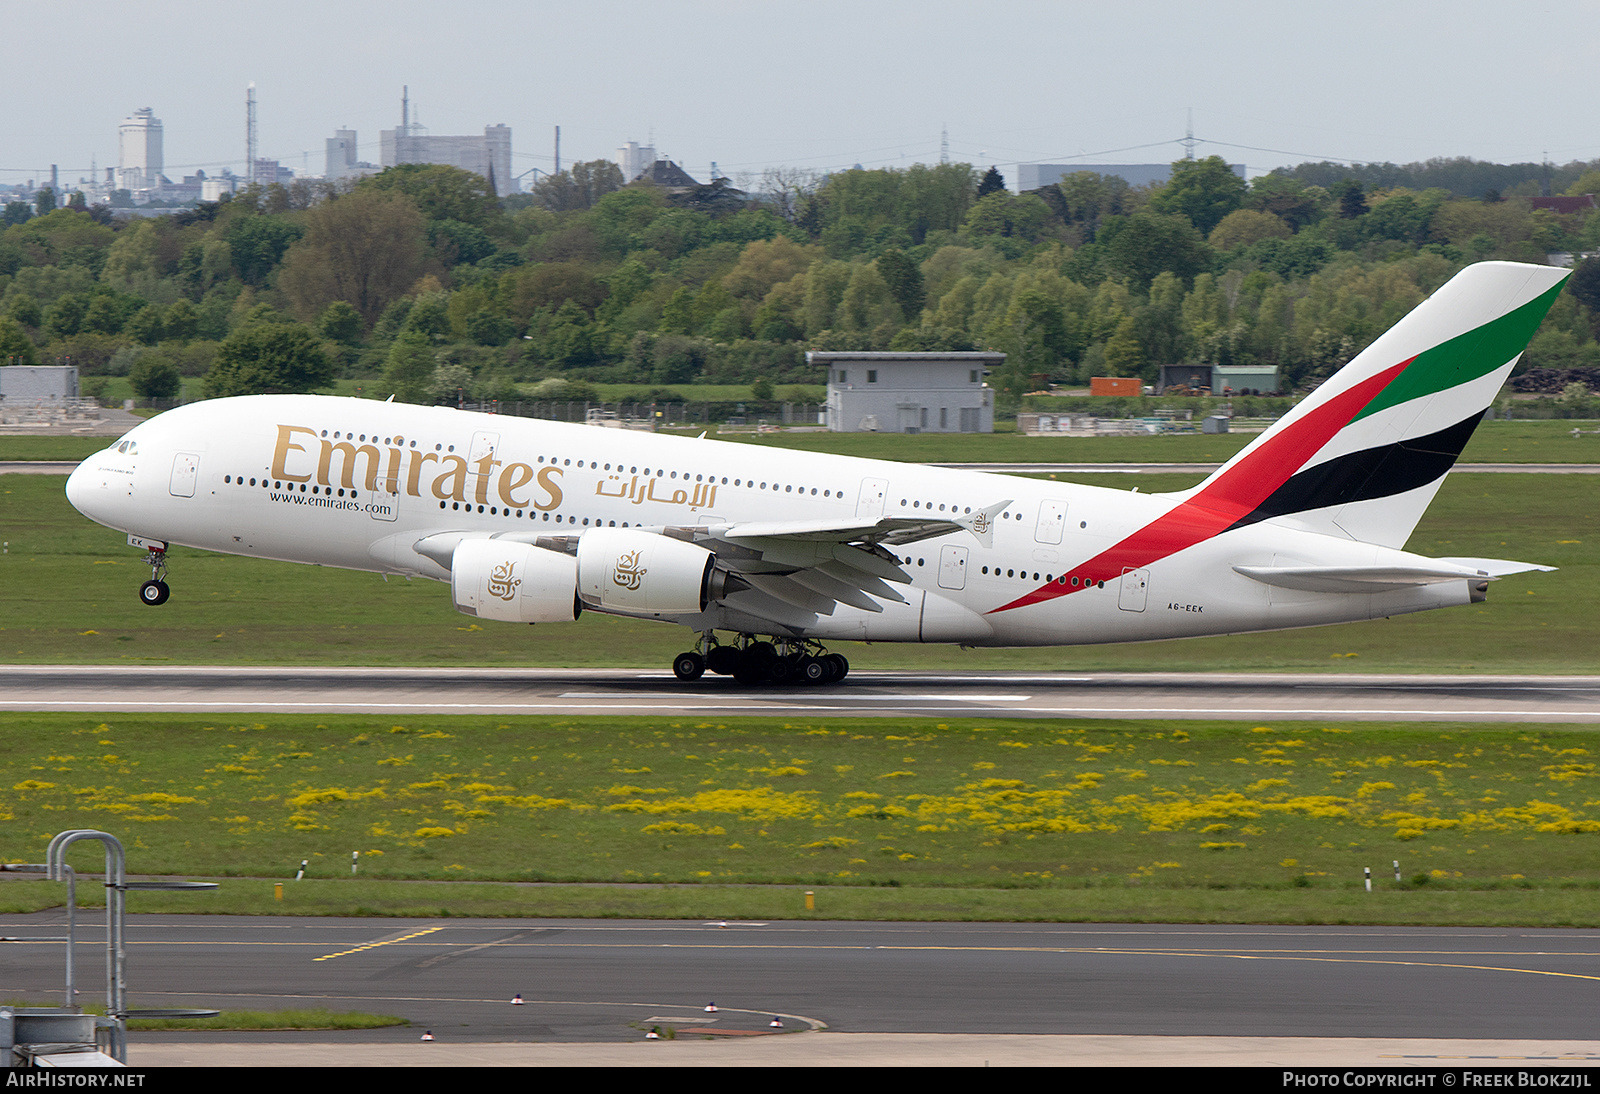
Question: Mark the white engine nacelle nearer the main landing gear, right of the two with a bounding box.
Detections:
[578,528,717,616]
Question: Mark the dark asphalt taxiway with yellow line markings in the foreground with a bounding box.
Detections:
[9,914,1600,1048]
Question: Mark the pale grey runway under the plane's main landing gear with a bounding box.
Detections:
[0,665,1600,723]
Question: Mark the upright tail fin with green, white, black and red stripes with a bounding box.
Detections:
[1187,262,1570,547]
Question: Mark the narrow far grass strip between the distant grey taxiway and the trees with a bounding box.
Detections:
[0,421,1600,464]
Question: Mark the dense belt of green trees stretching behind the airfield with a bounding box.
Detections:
[0,157,1600,401]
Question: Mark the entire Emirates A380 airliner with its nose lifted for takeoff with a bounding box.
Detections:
[67,262,1568,683]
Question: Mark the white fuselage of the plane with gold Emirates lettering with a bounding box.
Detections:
[67,395,1470,646]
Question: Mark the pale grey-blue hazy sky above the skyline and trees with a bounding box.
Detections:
[0,0,1600,191]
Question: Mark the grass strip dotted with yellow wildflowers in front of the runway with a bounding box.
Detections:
[9,713,1600,923]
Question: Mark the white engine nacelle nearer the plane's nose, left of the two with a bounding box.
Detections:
[450,539,582,622]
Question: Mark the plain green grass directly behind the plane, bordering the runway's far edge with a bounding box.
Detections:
[0,475,1600,673]
